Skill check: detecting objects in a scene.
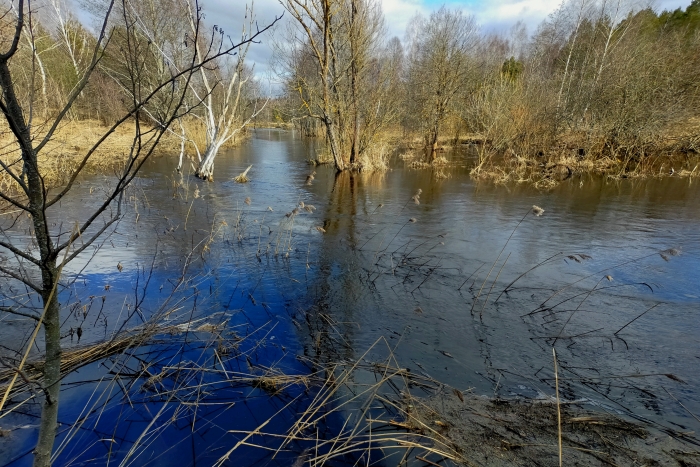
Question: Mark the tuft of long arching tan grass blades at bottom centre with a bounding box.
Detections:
[215,338,468,466]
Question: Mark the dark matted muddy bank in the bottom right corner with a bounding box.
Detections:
[404,390,700,466]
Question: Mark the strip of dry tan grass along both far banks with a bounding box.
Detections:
[5,118,700,192]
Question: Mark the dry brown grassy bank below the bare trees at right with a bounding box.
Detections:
[396,119,700,188]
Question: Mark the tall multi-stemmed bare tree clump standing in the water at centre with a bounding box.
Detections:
[282,0,400,171]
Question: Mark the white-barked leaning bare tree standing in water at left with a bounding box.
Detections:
[100,0,267,181]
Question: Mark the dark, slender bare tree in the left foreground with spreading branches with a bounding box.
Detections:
[0,0,278,466]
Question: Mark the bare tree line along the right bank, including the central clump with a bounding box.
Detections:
[273,0,700,174]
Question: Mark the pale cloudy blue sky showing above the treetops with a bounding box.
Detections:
[189,0,690,88]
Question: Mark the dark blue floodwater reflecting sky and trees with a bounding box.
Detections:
[0,130,700,466]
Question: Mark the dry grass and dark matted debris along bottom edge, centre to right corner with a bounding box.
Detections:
[205,332,696,466]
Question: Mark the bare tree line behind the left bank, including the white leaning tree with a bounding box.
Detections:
[0,0,266,180]
